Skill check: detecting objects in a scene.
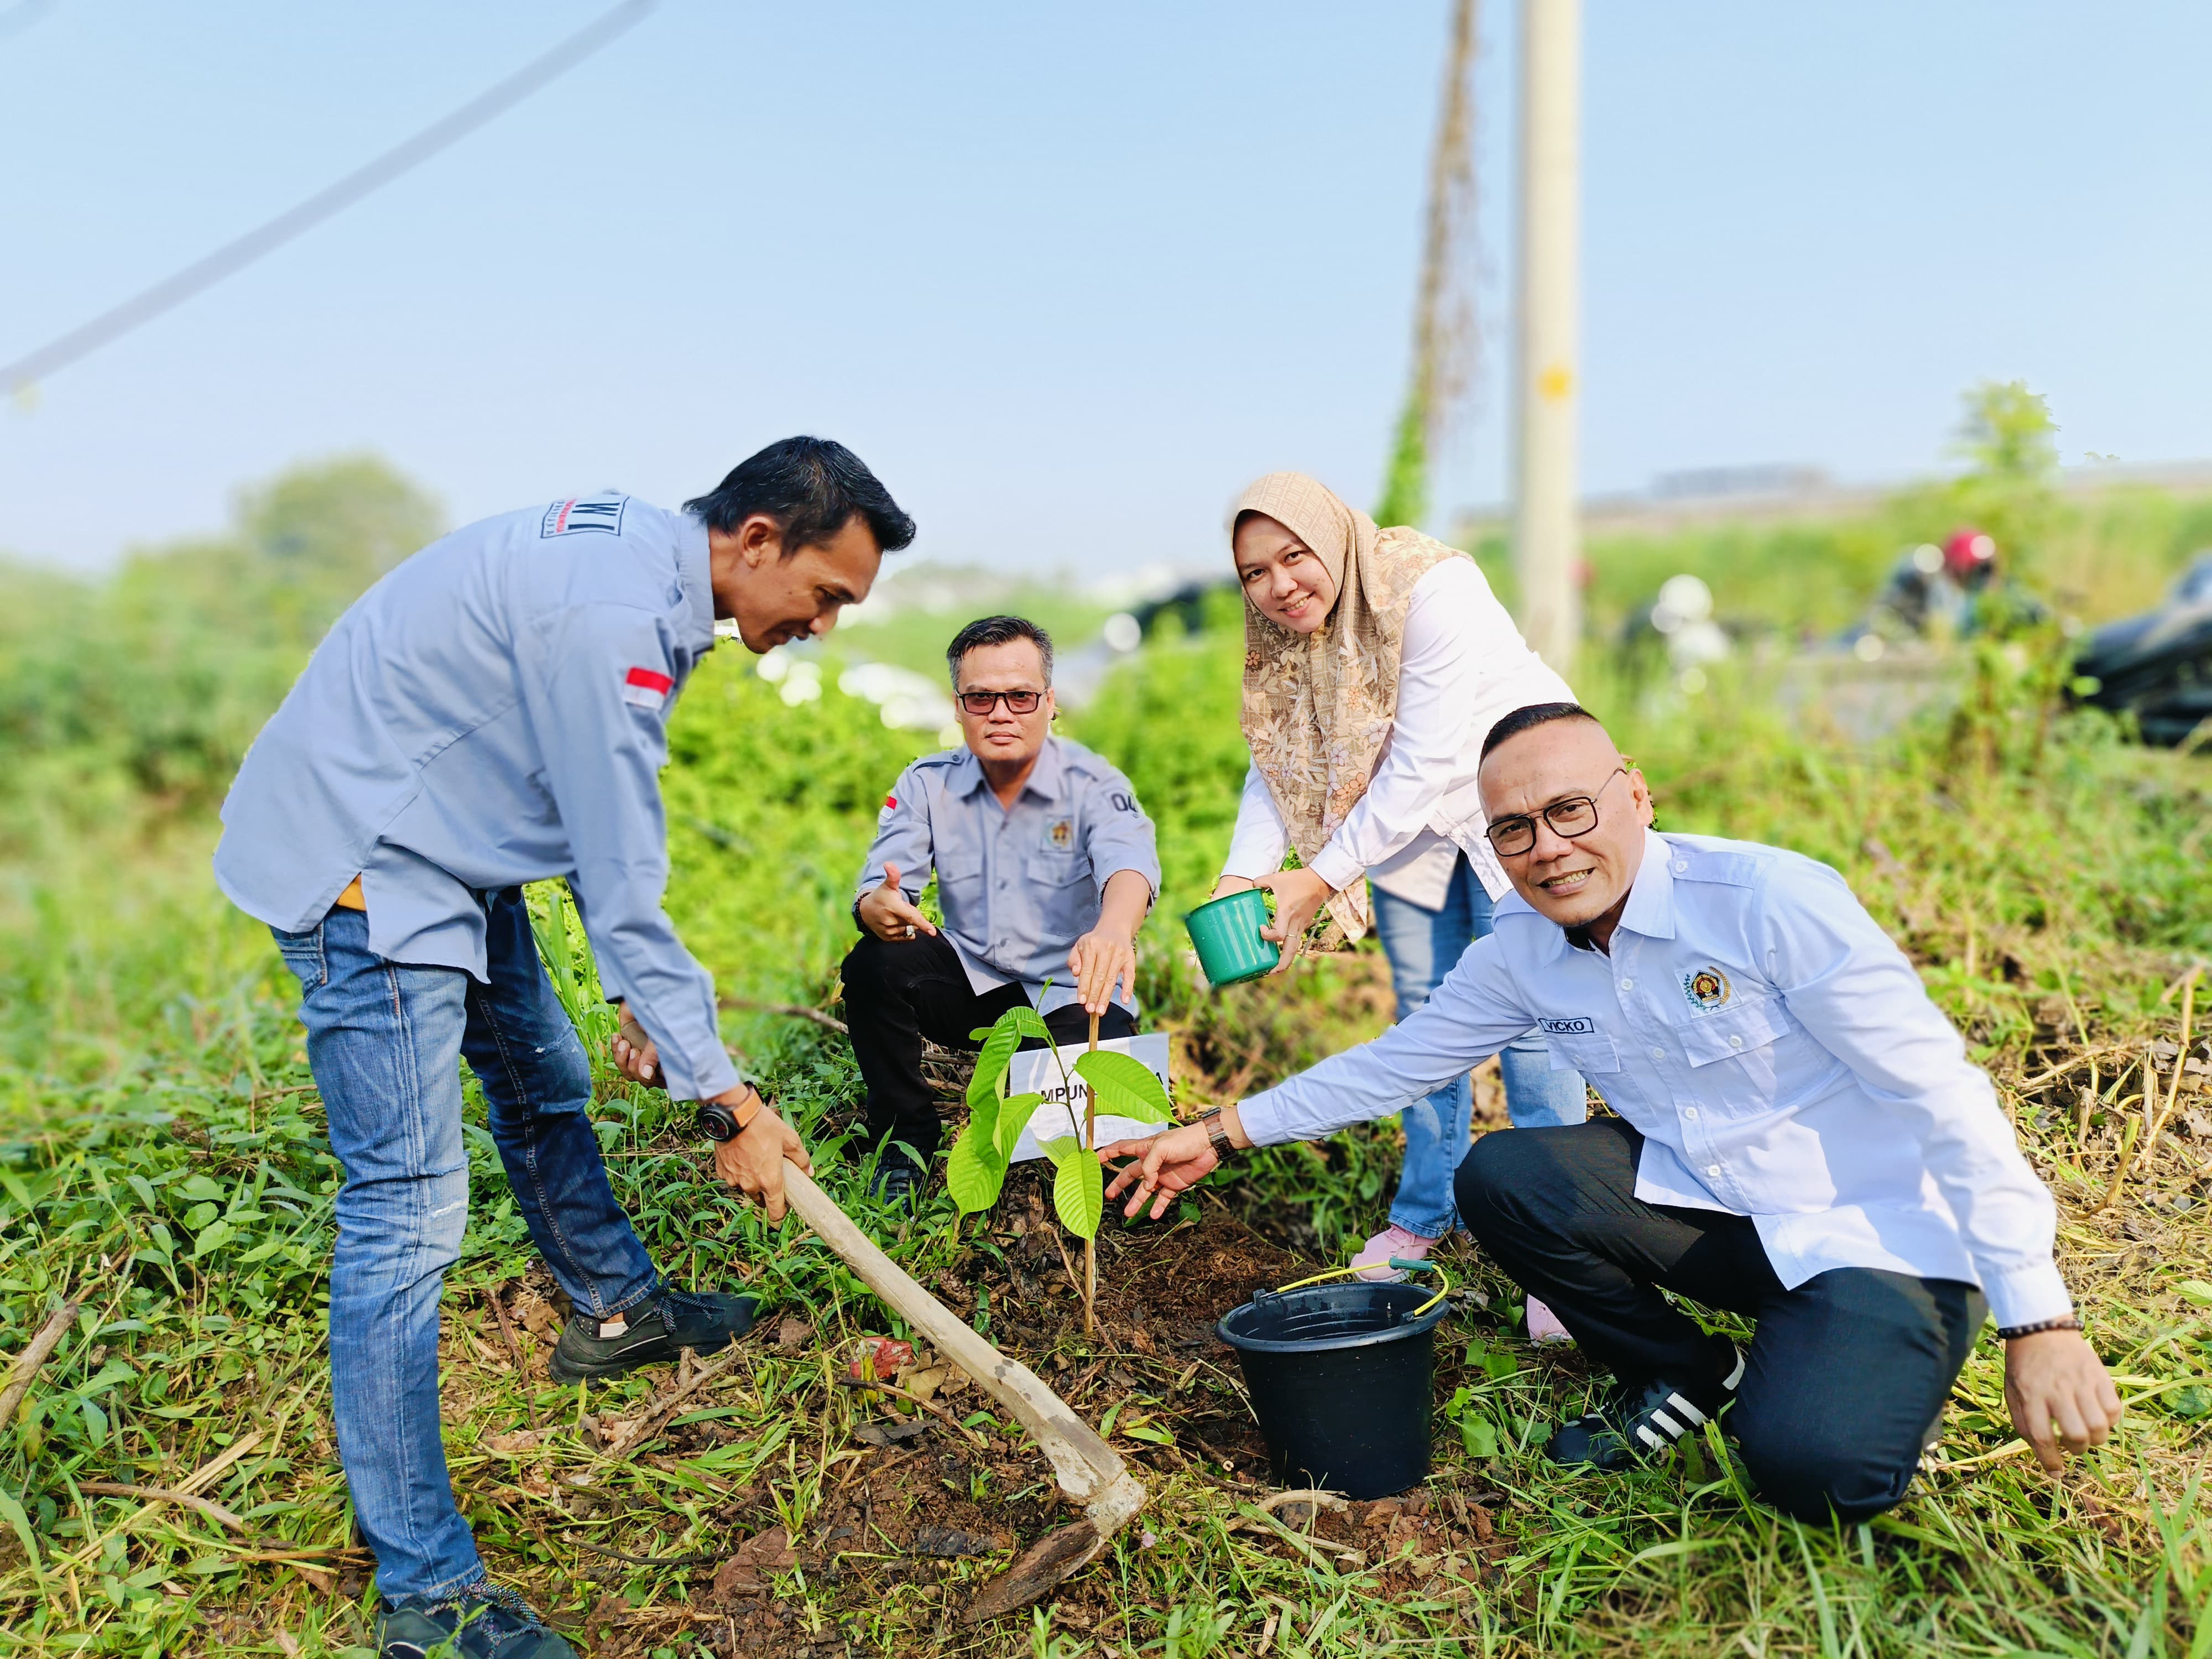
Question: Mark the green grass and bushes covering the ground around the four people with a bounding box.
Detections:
[0,449,2212,1659]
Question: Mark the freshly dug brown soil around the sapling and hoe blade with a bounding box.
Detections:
[562,1164,1506,1655]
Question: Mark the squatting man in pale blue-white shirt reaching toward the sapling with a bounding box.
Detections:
[1099,703,2119,1522]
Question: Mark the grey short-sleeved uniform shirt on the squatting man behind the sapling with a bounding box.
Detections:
[854,737,1159,1013]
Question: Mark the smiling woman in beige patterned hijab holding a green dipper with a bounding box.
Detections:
[1214,473,1586,1340]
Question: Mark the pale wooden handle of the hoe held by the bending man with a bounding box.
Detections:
[783,1159,1144,1540]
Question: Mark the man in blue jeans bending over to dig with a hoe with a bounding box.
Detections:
[215,438,914,1659]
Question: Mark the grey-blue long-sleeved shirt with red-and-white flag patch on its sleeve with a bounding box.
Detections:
[215,493,737,1099]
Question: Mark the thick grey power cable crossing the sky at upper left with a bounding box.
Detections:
[0,0,659,394]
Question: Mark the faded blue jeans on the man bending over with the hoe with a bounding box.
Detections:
[276,887,659,1601]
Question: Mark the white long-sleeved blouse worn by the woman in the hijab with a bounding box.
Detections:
[1221,560,1575,909]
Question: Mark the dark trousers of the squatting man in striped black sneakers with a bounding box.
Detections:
[1455,1117,1989,1524]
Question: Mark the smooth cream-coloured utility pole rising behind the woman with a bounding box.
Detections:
[1513,0,1582,672]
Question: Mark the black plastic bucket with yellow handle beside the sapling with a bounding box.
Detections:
[1214,1281,1449,1498]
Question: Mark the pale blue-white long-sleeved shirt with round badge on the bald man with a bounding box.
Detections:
[1239,832,2073,1325]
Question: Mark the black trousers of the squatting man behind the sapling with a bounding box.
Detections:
[845,933,1137,1164]
